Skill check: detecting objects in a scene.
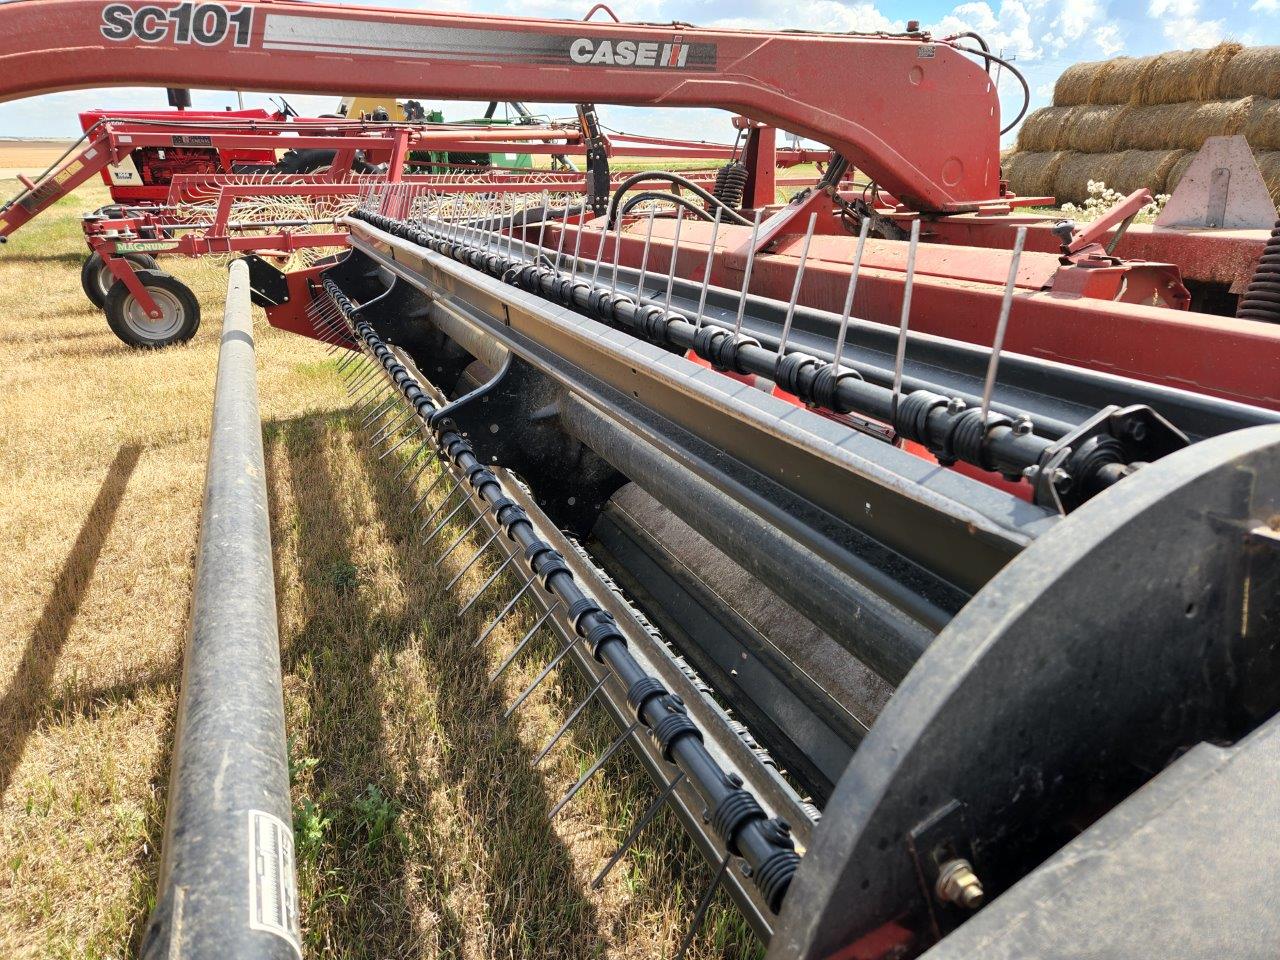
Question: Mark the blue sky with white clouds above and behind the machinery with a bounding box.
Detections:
[0,0,1280,141]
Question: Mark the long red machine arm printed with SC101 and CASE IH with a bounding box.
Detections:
[0,0,1000,211]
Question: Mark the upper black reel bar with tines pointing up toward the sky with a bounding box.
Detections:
[352,210,1152,506]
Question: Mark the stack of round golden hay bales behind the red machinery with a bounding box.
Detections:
[1004,44,1280,202]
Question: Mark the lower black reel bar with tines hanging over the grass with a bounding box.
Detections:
[324,278,800,913]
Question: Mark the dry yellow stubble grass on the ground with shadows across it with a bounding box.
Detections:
[0,184,758,959]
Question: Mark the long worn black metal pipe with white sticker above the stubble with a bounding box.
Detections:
[141,261,301,960]
